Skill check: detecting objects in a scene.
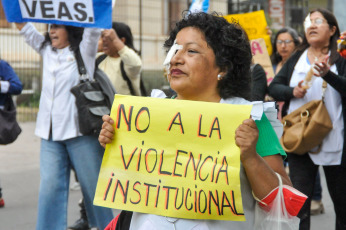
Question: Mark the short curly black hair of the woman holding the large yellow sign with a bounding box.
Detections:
[164,11,252,100]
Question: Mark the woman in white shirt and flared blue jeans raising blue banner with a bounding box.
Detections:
[16,23,113,230]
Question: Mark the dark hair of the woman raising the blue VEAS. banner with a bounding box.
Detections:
[41,26,84,52]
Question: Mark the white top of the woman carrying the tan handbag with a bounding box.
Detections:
[288,51,344,165]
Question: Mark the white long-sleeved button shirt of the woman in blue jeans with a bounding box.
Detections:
[20,23,100,141]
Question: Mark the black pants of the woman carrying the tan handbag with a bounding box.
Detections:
[288,154,346,230]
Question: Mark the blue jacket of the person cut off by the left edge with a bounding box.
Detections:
[0,60,23,105]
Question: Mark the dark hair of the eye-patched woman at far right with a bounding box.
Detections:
[298,8,340,64]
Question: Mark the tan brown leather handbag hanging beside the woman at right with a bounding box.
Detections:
[280,81,333,155]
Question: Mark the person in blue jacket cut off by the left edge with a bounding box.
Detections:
[0,56,23,208]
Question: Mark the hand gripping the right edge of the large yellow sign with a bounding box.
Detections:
[235,118,259,162]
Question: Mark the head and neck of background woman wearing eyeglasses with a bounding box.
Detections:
[271,27,300,74]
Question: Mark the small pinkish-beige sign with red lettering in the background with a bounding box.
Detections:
[250,38,274,85]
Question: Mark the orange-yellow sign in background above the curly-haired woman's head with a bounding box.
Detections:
[224,10,273,55]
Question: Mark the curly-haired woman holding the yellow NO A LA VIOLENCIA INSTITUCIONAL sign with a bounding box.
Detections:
[99,13,302,230]
